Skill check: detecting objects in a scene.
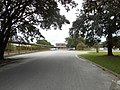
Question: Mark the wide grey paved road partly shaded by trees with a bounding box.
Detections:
[0,51,114,90]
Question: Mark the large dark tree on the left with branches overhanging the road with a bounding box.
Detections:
[0,0,76,60]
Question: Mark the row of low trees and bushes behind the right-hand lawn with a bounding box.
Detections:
[65,36,120,52]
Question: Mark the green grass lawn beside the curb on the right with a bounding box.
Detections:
[80,52,120,74]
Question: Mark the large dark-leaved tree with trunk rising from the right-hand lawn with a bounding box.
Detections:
[71,0,120,56]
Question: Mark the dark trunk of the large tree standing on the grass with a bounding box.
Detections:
[107,29,113,56]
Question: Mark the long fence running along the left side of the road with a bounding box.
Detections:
[4,42,50,56]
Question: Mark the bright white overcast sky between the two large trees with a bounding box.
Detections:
[41,0,83,45]
